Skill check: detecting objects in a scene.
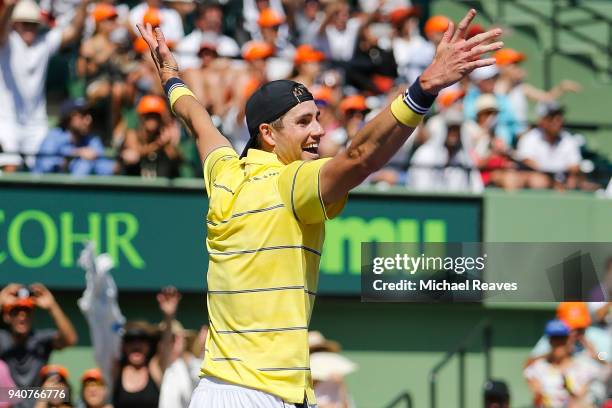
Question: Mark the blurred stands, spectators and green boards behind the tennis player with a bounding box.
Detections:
[0,0,612,408]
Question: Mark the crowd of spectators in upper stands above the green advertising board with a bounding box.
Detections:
[0,0,599,191]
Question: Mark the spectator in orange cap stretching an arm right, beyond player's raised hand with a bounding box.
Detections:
[494,48,582,129]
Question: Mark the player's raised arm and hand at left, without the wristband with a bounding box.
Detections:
[138,24,231,162]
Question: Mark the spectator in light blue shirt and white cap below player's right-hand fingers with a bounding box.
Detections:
[463,65,524,146]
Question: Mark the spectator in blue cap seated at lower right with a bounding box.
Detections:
[524,320,593,408]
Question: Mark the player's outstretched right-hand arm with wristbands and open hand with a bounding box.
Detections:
[320,9,503,204]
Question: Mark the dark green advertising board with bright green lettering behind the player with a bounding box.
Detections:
[0,179,482,295]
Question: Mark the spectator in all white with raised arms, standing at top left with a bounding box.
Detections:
[0,0,91,171]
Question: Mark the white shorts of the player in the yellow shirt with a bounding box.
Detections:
[189,377,316,408]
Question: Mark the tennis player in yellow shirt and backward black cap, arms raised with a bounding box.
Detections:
[139,10,503,408]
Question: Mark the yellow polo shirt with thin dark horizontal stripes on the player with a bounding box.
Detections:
[201,147,346,403]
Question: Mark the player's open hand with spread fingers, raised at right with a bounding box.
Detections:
[421,9,504,95]
